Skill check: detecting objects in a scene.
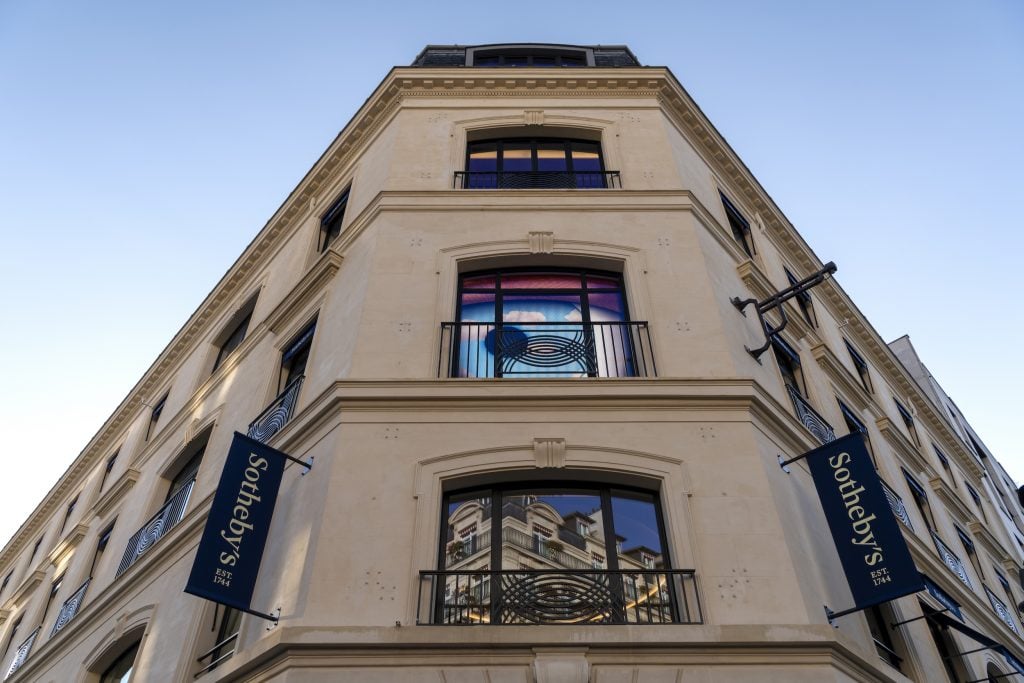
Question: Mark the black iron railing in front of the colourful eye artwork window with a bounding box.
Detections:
[437,321,657,378]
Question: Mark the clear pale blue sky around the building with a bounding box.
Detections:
[0,0,1024,542]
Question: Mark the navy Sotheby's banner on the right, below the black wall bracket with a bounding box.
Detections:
[807,432,925,609]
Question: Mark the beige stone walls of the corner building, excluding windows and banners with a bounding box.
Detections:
[0,60,1021,683]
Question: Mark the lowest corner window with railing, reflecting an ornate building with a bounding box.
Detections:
[425,482,700,624]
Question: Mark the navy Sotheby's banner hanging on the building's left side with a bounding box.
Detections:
[185,432,287,610]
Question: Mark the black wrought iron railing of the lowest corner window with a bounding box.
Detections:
[416,569,703,626]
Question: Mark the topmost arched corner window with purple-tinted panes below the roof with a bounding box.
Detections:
[462,138,607,189]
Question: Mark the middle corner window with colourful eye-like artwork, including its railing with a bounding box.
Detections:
[441,268,655,378]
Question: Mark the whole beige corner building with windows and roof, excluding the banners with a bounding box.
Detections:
[0,45,1024,683]
